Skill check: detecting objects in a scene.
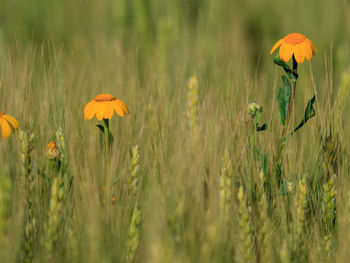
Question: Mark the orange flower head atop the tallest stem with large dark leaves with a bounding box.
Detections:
[271,33,317,64]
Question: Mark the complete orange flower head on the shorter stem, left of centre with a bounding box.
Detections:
[84,94,130,121]
